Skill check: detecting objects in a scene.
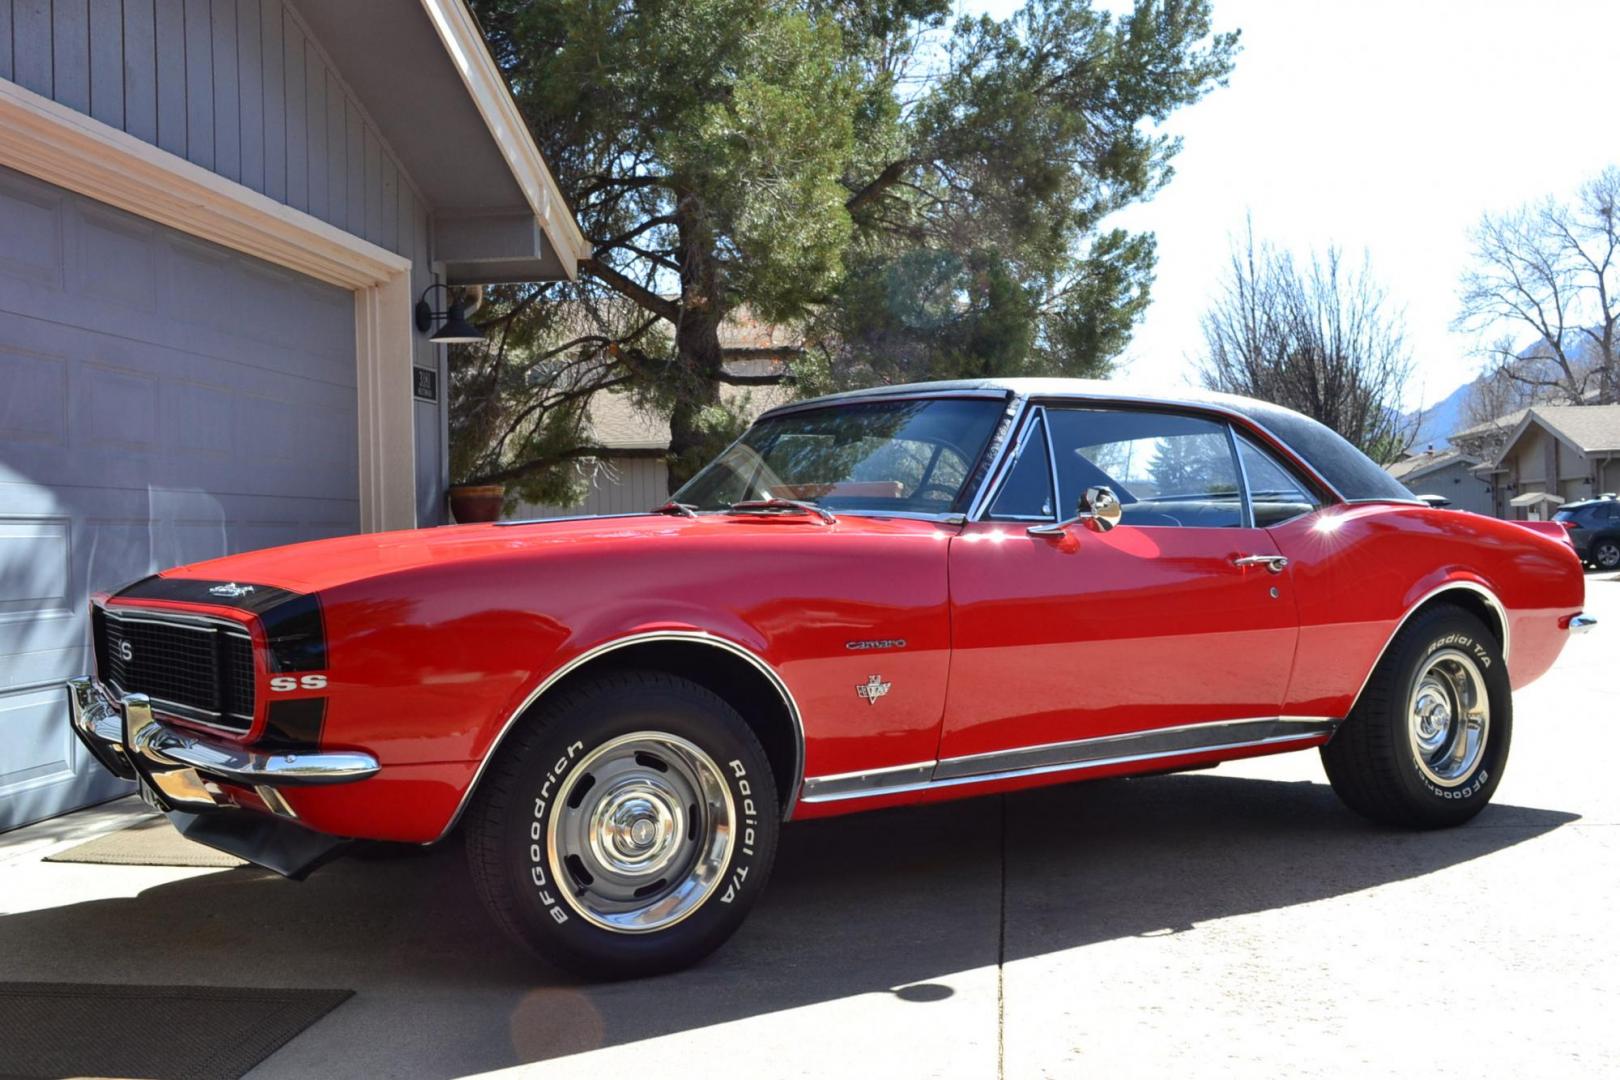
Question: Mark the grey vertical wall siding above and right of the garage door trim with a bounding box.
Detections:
[0,0,447,525]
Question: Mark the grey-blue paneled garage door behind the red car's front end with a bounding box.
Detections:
[0,168,360,829]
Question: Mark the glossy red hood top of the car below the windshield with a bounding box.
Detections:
[160,513,936,593]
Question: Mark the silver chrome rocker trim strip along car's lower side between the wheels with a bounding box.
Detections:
[800,716,1340,803]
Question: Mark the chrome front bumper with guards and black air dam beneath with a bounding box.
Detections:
[68,677,381,878]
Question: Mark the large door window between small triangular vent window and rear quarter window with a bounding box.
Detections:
[1047,408,1243,528]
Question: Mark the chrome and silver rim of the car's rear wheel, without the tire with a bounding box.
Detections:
[1406,649,1490,787]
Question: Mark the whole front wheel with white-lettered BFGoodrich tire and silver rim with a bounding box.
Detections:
[467,672,779,978]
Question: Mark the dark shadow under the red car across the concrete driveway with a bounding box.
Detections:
[0,774,1576,1077]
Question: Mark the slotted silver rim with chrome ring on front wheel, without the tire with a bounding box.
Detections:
[546,732,737,934]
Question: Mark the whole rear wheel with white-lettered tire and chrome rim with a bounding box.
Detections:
[1322,606,1513,829]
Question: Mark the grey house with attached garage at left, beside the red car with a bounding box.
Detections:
[0,0,586,829]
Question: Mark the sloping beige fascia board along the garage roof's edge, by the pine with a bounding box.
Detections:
[421,0,591,282]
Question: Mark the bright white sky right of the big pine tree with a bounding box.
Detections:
[957,0,1620,406]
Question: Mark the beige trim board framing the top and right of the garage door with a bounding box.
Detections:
[0,79,417,533]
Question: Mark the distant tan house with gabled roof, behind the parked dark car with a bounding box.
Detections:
[1474,405,1620,520]
